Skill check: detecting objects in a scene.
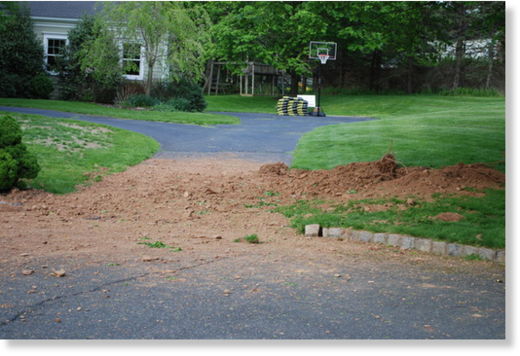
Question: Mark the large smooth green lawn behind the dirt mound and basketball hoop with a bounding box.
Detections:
[207,95,505,170]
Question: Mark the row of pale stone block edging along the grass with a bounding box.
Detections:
[305,224,506,263]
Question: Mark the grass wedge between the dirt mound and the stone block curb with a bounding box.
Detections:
[274,190,505,248]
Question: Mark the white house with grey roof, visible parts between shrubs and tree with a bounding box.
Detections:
[21,1,167,81]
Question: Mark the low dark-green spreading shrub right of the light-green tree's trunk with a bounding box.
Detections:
[151,79,208,112]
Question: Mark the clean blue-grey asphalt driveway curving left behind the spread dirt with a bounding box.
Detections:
[0,106,370,164]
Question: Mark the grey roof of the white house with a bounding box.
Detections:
[21,1,100,19]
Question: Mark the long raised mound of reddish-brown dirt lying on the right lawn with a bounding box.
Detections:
[259,155,505,198]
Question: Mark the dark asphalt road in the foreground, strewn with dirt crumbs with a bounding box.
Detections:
[0,247,505,339]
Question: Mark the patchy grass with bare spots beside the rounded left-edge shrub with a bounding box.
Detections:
[6,113,159,194]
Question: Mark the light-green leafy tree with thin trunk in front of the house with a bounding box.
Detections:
[102,1,210,95]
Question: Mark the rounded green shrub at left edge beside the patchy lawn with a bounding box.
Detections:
[0,115,40,191]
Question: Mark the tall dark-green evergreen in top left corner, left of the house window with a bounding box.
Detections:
[0,2,53,98]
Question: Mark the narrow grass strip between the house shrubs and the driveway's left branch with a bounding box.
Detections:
[0,98,240,125]
